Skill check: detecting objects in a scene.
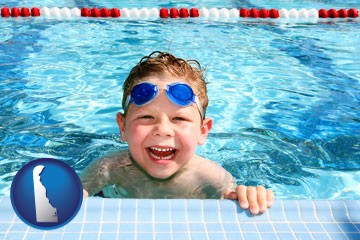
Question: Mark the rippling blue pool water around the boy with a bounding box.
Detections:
[0,0,360,202]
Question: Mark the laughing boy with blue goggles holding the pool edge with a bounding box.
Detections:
[81,52,274,214]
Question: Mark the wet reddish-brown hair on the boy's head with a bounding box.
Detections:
[122,51,209,117]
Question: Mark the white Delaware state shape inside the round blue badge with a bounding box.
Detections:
[33,165,58,222]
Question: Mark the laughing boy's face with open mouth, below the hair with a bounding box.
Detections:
[117,76,212,179]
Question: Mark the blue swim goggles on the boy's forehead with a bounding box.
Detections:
[124,82,204,119]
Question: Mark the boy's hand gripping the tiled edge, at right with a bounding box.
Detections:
[224,185,274,215]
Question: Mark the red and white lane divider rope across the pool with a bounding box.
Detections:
[1,7,359,19]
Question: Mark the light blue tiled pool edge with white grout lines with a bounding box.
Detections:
[0,197,360,240]
